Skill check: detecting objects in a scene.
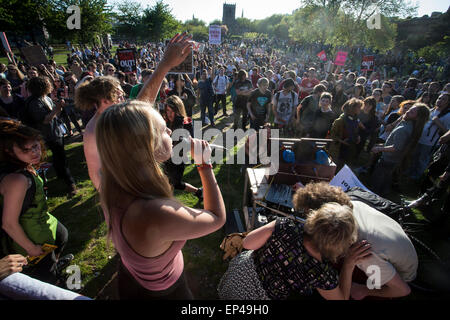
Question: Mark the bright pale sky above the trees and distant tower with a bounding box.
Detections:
[108,0,450,23]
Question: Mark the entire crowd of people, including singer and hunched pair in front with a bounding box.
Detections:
[0,34,450,299]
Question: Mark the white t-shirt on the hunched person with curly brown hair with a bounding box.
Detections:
[352,201,419,286]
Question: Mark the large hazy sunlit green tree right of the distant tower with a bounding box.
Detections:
[288,0,417,52]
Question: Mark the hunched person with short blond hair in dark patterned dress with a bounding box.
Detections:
[217,198,370,300]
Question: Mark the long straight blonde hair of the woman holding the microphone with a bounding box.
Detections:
[95,101,173,234]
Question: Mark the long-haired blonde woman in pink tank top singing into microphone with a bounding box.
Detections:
[95,101,226,299]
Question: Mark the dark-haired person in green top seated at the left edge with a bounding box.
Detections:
[0,120,73,282]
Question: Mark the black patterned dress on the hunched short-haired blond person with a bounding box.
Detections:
[218,218,339,300]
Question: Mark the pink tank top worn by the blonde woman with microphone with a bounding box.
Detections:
[110,204,186,291]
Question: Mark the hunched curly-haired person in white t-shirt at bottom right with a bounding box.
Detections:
[293,182,418,300]
